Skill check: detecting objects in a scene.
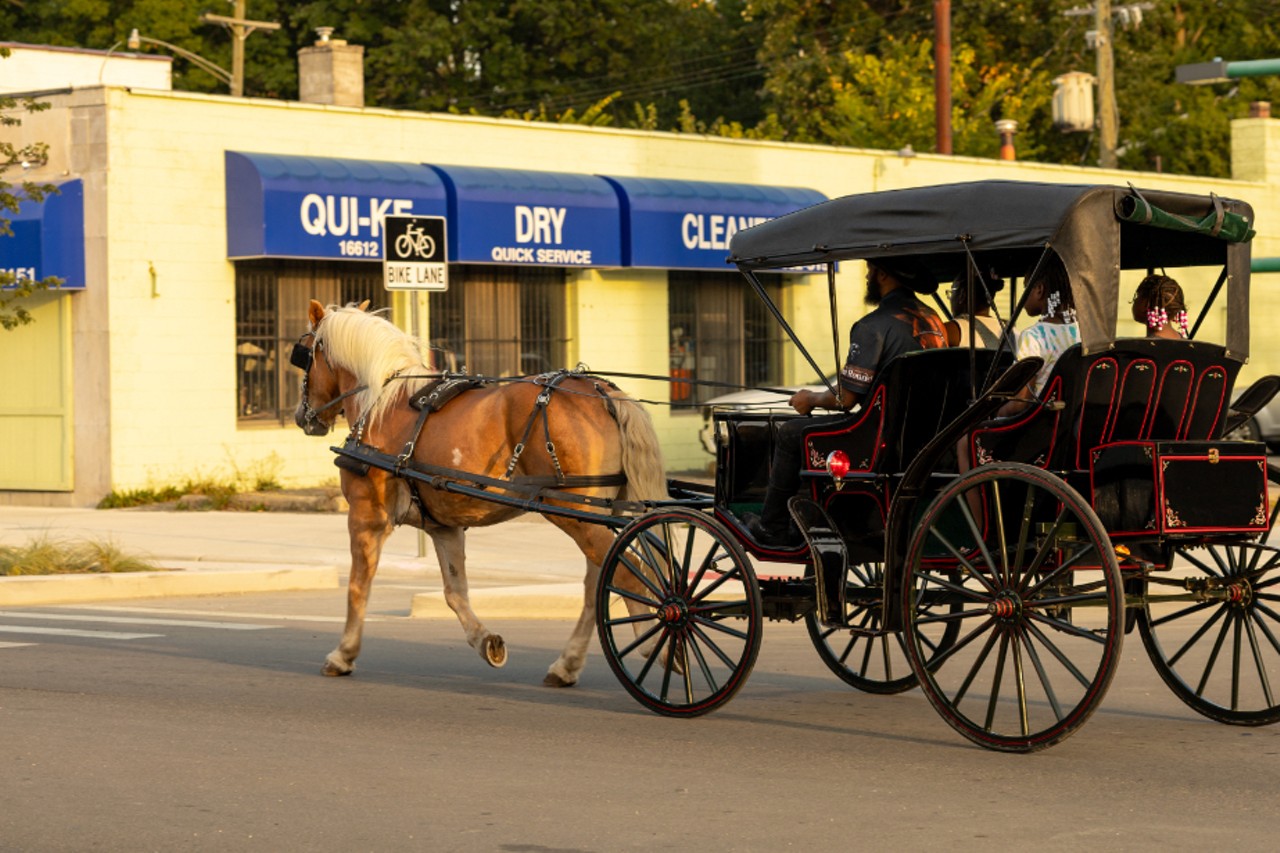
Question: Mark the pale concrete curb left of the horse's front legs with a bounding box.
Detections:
[0,566,338,607]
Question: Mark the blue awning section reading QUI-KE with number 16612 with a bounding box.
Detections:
[227,151,445,260]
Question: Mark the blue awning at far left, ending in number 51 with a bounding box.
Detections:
[0,179,84,291]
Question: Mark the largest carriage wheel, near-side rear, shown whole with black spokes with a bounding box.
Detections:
[902,462,1124,752]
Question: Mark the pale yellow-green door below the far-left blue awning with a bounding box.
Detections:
[0,293,73,492]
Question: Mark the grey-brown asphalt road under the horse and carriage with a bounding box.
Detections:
[0,587,1280,852]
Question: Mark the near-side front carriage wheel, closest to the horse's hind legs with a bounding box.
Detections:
[596,507,762,717]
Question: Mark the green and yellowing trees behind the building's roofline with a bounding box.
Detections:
[0,0,1280,174]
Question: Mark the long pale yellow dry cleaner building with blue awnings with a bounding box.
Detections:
[0,40,1280,505]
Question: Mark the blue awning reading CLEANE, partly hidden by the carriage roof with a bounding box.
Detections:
[607,177,827,272]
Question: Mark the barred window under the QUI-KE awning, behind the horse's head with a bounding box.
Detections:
[236,260,389,424]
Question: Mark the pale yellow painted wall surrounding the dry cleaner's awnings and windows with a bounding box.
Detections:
[12,90,1280,489]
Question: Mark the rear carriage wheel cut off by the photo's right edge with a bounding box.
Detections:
[1138,535,1280,726]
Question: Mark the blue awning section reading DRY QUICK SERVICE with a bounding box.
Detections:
[434,165,622,266]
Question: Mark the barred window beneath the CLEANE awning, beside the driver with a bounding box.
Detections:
[667,272,782,409]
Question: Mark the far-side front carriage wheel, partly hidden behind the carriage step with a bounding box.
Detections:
[804,562,954,695]
